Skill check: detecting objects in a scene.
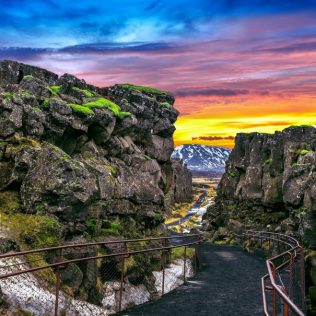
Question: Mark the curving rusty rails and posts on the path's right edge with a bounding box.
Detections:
[242,230,305,316]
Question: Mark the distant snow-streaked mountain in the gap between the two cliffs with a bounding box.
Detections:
[172,144,231,173]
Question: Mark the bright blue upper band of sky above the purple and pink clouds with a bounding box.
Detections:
[0,0,316,48]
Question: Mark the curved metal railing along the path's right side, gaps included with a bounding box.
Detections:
[242,231,305,316]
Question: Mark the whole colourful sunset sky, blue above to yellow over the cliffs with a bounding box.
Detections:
[0,0,316,147]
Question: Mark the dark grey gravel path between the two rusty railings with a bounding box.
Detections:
[120,244,266,316]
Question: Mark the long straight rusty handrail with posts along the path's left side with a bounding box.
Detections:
[0,234,204,316]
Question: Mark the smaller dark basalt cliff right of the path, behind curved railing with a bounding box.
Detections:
[205,126,316,310]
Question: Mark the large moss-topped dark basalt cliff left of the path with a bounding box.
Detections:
[0,61,191,314]
